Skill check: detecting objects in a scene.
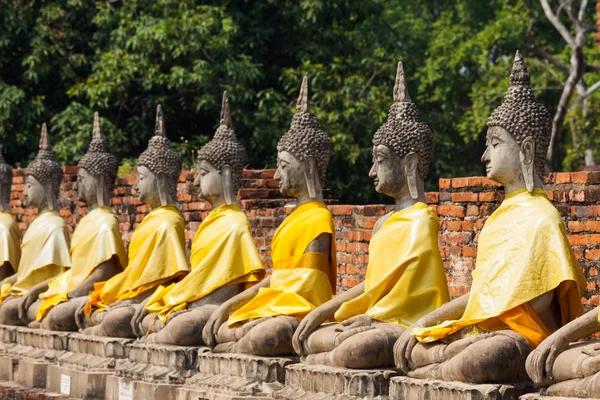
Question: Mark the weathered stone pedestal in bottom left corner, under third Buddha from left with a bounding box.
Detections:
[0,327,69,388]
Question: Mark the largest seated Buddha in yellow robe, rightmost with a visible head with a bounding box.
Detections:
[394,52,586,384]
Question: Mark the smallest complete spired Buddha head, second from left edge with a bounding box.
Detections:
[25,124,63,211]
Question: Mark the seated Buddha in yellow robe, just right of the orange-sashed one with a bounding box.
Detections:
[293,63,449,368]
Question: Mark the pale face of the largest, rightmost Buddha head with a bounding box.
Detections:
[481,126,523,186]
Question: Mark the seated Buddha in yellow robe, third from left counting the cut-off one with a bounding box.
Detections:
[23,113,127,331]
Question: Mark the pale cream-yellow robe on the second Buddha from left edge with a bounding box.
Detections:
[3,210,71,296]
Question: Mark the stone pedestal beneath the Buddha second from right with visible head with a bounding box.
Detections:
[274,363,398,399]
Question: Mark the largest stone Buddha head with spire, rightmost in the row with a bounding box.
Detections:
[481,51,552,192]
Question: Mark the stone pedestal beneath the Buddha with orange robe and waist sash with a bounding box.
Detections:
[177,350,298,400]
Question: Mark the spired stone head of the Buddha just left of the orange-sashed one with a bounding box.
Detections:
[194,91,246,207]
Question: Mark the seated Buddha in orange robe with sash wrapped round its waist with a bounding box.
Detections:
[202,77,337,356]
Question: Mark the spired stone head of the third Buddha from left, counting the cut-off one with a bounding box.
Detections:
[77,112,119,207]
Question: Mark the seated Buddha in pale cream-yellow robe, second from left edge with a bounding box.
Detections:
[0,124,71,325]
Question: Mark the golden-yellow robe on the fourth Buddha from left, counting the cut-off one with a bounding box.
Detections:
[84,204,189,316]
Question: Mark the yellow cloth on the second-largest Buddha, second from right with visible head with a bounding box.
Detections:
[335,203,449,328]
